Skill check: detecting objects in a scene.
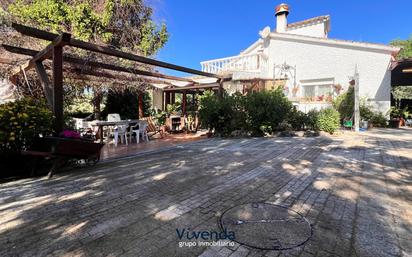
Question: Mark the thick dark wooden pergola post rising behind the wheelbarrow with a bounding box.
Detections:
[53,45,64,134]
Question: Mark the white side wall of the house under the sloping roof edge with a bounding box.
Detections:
[268,38,391,113]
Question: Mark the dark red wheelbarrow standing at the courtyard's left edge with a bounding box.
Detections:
[22,137,104,178]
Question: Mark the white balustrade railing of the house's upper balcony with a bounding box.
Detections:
[200,53,267,74]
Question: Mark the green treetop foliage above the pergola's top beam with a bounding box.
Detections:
[8,0,169,56]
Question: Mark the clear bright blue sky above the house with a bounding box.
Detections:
[148,0,412,75]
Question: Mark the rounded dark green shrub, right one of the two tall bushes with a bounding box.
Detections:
[245,88,292,136]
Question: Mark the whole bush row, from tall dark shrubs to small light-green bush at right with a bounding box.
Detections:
[199,90,340,136]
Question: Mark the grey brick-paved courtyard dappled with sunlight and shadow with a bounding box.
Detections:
[0,129,412,257]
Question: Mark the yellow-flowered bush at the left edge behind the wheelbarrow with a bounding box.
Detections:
[0,98,53,153]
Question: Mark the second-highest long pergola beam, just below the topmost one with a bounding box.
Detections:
[2,44,194,83]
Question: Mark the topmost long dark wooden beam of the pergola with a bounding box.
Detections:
[12,23,220,78]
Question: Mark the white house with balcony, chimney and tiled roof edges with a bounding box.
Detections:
[201,4,400,113]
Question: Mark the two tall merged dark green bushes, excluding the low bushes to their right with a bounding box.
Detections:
[199,90,292,136]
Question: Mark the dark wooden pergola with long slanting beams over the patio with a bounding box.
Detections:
[2,23,224,133]
